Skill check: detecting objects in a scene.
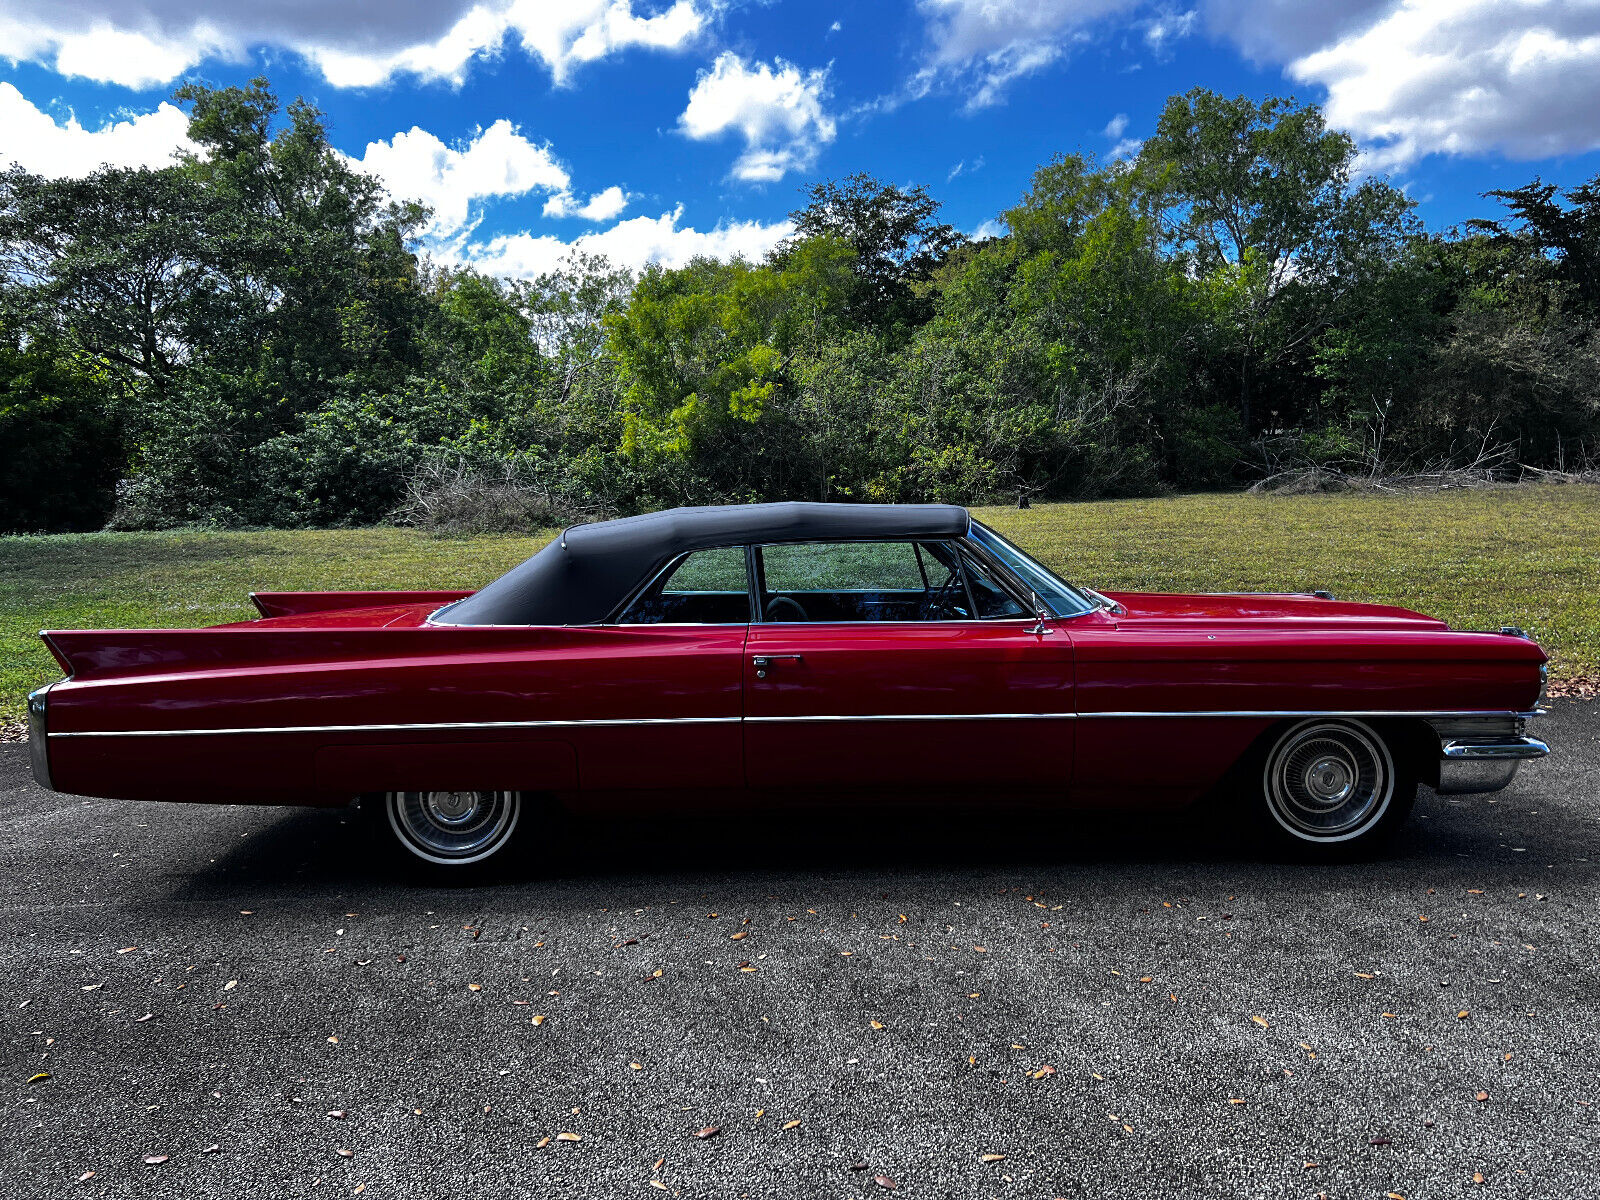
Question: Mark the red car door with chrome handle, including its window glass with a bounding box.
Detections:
[744,542,1074,795]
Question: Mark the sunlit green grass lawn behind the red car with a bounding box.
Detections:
[0,485,1600,722]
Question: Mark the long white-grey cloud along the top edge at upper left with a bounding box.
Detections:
[0,0,715,88]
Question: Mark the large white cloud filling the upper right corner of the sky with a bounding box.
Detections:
[1288,0,1600,170]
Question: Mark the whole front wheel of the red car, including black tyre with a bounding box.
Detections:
[1261,718,1416,858]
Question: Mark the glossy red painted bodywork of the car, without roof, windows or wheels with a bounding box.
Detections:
[34,592,1544,808]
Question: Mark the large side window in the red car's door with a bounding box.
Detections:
[760,541,971,622]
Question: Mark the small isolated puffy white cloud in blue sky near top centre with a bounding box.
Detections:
[678,51,835,182]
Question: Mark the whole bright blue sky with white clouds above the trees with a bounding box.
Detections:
[0,0,1600,275]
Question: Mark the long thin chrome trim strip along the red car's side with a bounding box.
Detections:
[46,709,1549,739]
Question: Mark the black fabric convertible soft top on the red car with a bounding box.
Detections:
[438,502,971,626]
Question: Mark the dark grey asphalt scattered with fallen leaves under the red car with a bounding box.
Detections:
[0,701,1600,1200]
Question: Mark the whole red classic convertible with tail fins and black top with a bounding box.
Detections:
[29,504,1549,872]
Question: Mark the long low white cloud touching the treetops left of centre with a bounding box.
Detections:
[448,205,794,278]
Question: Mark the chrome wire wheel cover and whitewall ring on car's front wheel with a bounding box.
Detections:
[1262,720,1395,842]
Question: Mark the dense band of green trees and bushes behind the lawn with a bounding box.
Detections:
[0,82,1600,530]
